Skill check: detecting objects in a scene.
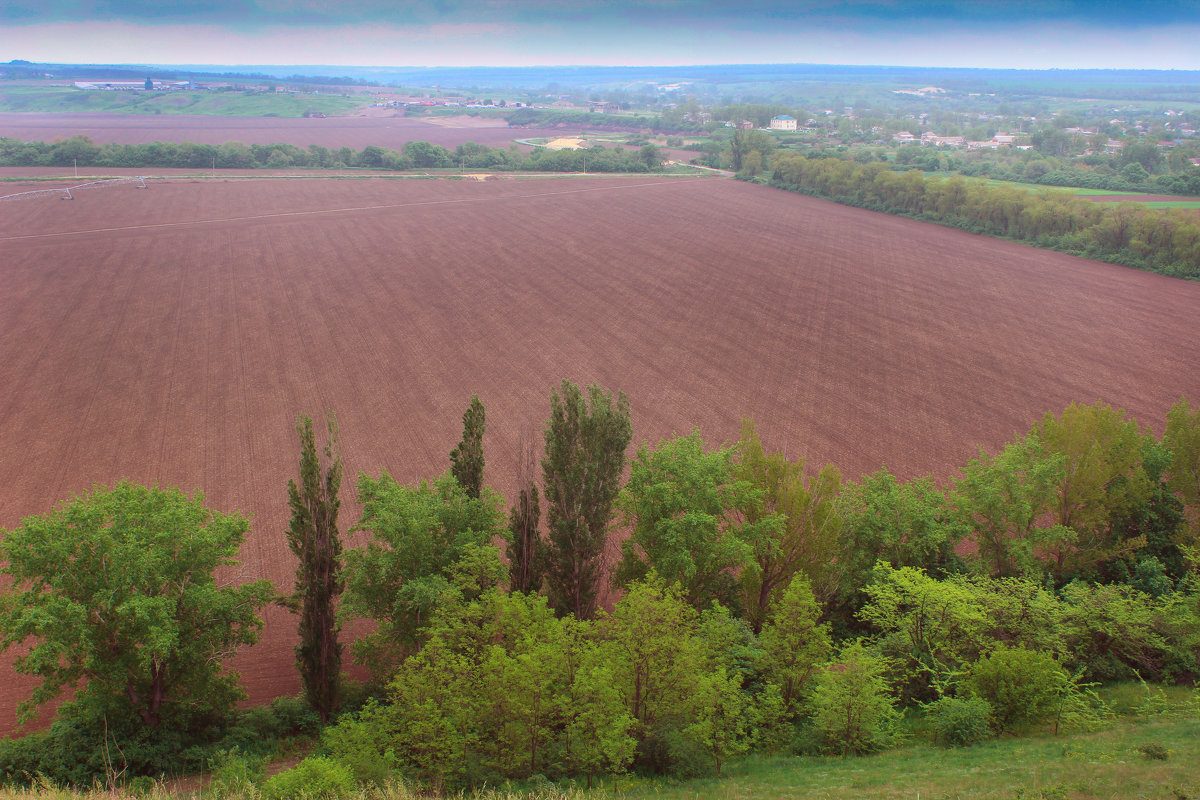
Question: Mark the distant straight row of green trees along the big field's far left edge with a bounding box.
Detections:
[0,136,661,173]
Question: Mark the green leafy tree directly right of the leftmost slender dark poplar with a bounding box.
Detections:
[341,471,503,679]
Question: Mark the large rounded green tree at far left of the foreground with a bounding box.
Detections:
[0,483,274,728]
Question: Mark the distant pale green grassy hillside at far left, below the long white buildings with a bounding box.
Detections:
[0,86,362,116]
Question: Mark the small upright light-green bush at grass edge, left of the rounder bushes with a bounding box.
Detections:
[812,639,901,756]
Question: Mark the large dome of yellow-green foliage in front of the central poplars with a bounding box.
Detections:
[380,591,634,789]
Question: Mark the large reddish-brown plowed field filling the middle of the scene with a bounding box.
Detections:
[0,178,1200,728]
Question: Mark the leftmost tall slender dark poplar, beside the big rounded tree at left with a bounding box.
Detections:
[284,414,346,722]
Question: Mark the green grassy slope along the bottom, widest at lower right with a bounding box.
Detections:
[0,710,1200,800]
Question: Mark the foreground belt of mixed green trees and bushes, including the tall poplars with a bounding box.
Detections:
[0,381,1200,796]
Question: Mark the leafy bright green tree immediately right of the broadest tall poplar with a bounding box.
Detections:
[617,431,750,608]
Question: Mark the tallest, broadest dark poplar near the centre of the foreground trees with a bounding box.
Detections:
[541,380,634,619]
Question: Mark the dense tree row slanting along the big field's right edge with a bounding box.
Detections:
[770,156,1200,278]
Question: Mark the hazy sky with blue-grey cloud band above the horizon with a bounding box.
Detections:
[0,0,1200,70]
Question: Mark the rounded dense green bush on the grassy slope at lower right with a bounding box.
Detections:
[966,645,1072,730]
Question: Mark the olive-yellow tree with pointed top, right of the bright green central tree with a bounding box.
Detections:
[733,420,844,631]
